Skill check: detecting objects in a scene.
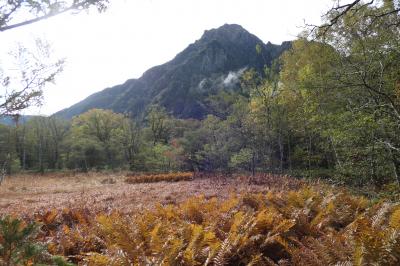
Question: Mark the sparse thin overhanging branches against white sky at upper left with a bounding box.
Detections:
[0,0,108,117]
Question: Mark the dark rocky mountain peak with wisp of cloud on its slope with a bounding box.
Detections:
[55,24,290,119]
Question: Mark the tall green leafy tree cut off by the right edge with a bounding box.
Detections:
[316,1,400,185]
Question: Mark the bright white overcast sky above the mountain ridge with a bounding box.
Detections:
[0,0,332,115]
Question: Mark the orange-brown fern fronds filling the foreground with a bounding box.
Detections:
[0,175,400,265]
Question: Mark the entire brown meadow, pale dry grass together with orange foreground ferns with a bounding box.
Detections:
[0,173,400,265]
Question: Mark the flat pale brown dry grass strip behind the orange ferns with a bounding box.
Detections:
[0,173,303,216]
